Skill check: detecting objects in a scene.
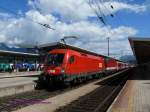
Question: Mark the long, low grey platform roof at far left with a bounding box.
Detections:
[0,50,39,57]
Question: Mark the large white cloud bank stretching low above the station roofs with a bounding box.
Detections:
[0,10,137,57]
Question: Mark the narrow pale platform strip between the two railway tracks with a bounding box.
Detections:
[14,70,129,112]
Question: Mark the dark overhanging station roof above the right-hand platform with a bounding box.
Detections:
[129,37,150,64]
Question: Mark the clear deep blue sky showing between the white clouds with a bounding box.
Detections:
[0,0,150,37]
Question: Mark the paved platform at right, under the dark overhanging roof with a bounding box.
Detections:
[107,66,150,112]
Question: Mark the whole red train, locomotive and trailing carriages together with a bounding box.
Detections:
[38,48,129,85]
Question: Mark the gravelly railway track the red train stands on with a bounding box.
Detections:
[0,79,98,112]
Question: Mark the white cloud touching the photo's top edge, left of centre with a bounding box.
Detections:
[29,0,93,21]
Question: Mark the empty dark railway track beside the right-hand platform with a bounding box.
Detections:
[56,68,131,112]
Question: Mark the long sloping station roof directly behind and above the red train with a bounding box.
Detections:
[38,42,124,62]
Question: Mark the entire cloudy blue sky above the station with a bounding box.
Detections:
[0,0,150,57]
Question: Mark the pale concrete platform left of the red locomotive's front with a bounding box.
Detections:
[0,72,39,97]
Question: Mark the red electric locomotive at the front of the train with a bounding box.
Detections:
[40,49,105,85]
